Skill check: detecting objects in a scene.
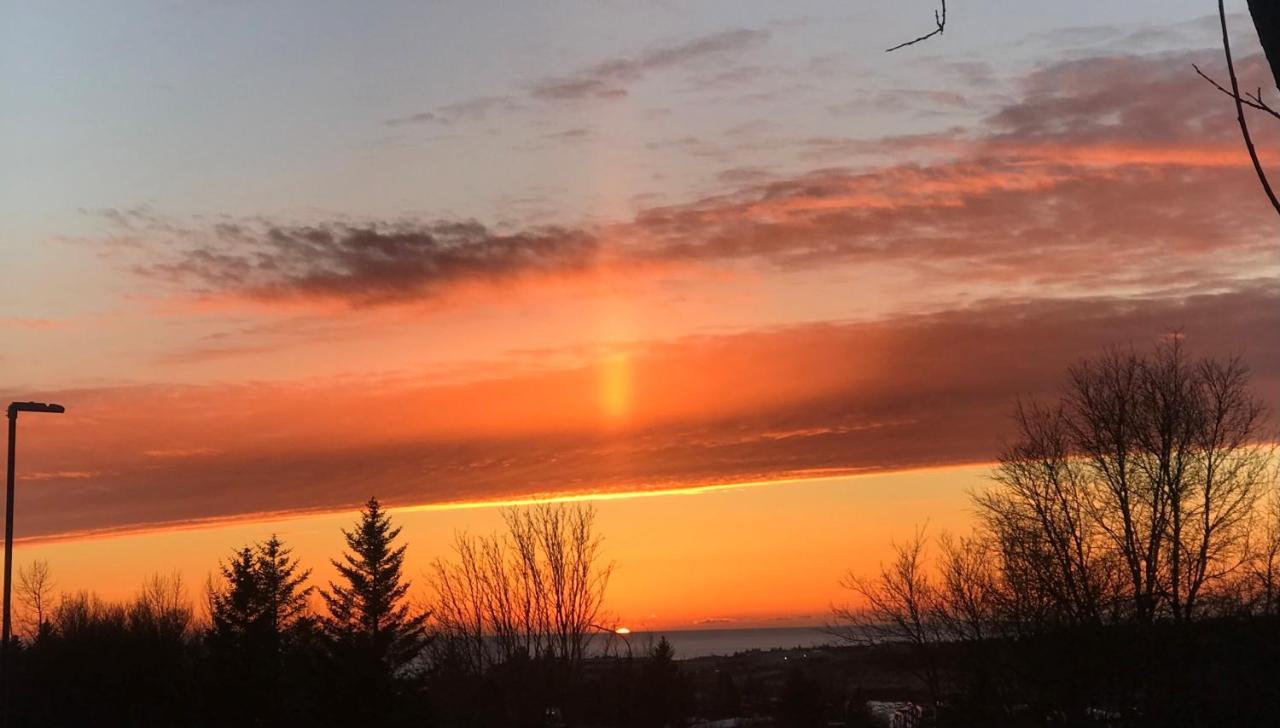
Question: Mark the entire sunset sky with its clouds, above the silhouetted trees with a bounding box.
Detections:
[0,0,1280,627]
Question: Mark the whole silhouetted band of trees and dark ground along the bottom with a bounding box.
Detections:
[5,338,1280,728]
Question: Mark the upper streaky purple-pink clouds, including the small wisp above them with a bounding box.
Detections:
[111,42,1275,306]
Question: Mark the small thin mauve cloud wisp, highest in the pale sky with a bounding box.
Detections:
[529,28,769,101]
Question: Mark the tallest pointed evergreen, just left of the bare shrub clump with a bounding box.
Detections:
[320,498,426,692]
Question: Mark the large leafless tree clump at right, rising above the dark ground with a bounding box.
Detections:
[835,335,1280,647]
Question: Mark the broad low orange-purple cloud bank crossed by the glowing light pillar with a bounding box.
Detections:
[5,279,1280,536]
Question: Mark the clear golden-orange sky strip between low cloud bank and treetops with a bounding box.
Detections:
[14,466,987,628]
